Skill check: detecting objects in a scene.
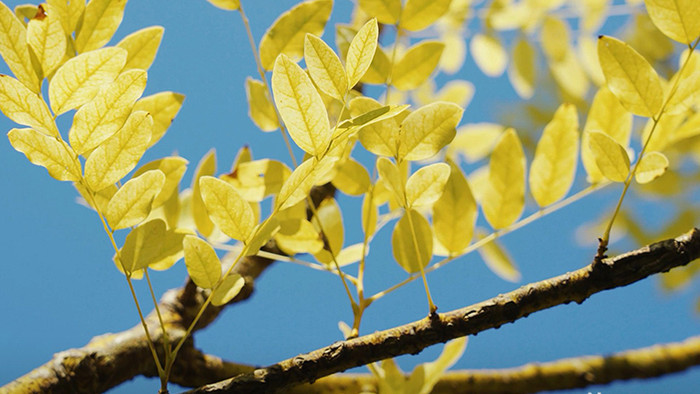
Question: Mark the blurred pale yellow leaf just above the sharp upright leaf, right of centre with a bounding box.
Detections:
[447,123,504,163]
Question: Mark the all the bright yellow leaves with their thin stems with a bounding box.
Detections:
[0,0,700,391]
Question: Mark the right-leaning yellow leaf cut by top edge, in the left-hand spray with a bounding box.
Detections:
[71,0,126,53]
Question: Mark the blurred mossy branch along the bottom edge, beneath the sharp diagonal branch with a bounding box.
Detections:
[178,336,700,394]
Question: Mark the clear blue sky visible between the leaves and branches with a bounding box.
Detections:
[0,0,700,393]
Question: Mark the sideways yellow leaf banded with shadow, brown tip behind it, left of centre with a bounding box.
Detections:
[222,159,291,202]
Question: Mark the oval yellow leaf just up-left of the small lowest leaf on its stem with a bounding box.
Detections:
[182,235,221,289]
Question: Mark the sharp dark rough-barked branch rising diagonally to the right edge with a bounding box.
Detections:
[189,229,700,393]
